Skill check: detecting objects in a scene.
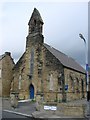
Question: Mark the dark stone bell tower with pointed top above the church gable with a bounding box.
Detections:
[26,8,44,48]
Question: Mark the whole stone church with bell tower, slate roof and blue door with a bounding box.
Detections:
[11,8,86,102]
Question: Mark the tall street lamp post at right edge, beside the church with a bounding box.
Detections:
[79,33,90,116]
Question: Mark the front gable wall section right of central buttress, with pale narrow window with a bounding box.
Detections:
[44,48,63,102]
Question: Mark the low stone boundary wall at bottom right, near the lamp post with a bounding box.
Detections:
[56,103,86,118]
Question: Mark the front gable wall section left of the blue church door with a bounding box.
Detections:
[11,53,29,99]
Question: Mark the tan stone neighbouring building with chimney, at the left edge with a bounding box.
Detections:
[0,52,14,97]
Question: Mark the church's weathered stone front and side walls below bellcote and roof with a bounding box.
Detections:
[12,37,86,102]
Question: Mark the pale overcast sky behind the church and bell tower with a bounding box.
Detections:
[0,2,88,68]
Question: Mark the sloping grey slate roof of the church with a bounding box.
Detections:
[44,44,85,73]
